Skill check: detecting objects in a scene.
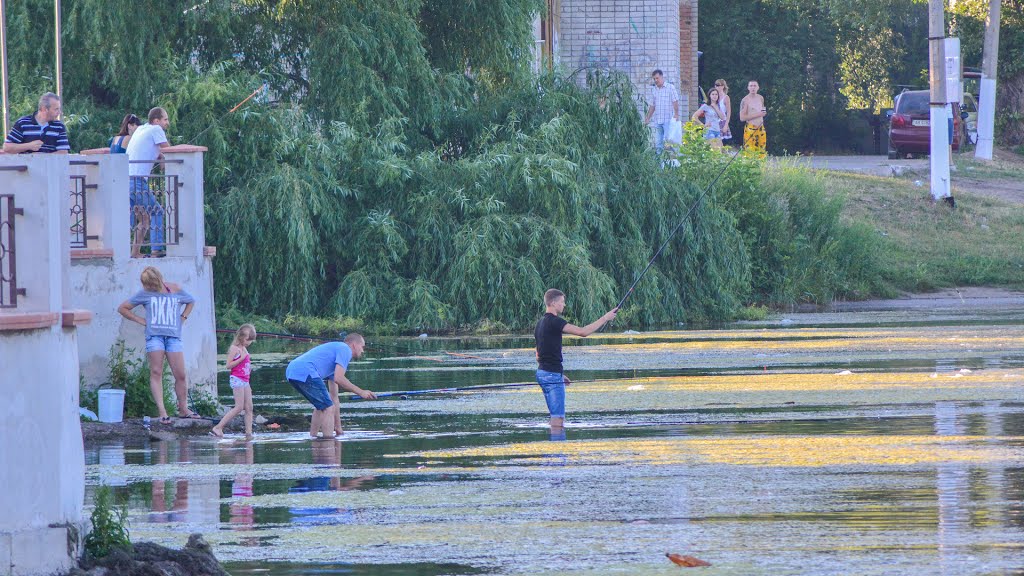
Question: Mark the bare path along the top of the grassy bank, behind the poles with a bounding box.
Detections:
[786,151,1024,204]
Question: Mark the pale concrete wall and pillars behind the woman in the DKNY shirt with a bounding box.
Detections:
[71,147,217,394]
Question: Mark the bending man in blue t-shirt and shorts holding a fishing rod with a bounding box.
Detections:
[285,332,377,438]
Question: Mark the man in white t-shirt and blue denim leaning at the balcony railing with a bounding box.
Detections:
[128,107,171,258]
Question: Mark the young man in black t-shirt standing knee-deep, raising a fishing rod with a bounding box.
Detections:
[534,288,618,429]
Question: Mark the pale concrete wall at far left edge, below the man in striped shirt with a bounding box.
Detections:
[0,155,88,576]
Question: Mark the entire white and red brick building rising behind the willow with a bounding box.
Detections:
[536,0,698,116]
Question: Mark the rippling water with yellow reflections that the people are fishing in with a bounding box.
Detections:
[86,306,1024,576]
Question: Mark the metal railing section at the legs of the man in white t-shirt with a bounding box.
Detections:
[129,170,181,251]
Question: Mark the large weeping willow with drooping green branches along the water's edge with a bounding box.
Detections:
[2,0,880,328]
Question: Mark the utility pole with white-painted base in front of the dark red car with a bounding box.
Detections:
[928,0,954,207]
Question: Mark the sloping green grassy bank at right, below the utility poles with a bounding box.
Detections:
[824,166,1024,295]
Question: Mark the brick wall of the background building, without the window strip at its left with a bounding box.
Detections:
[557,0,696,114]
